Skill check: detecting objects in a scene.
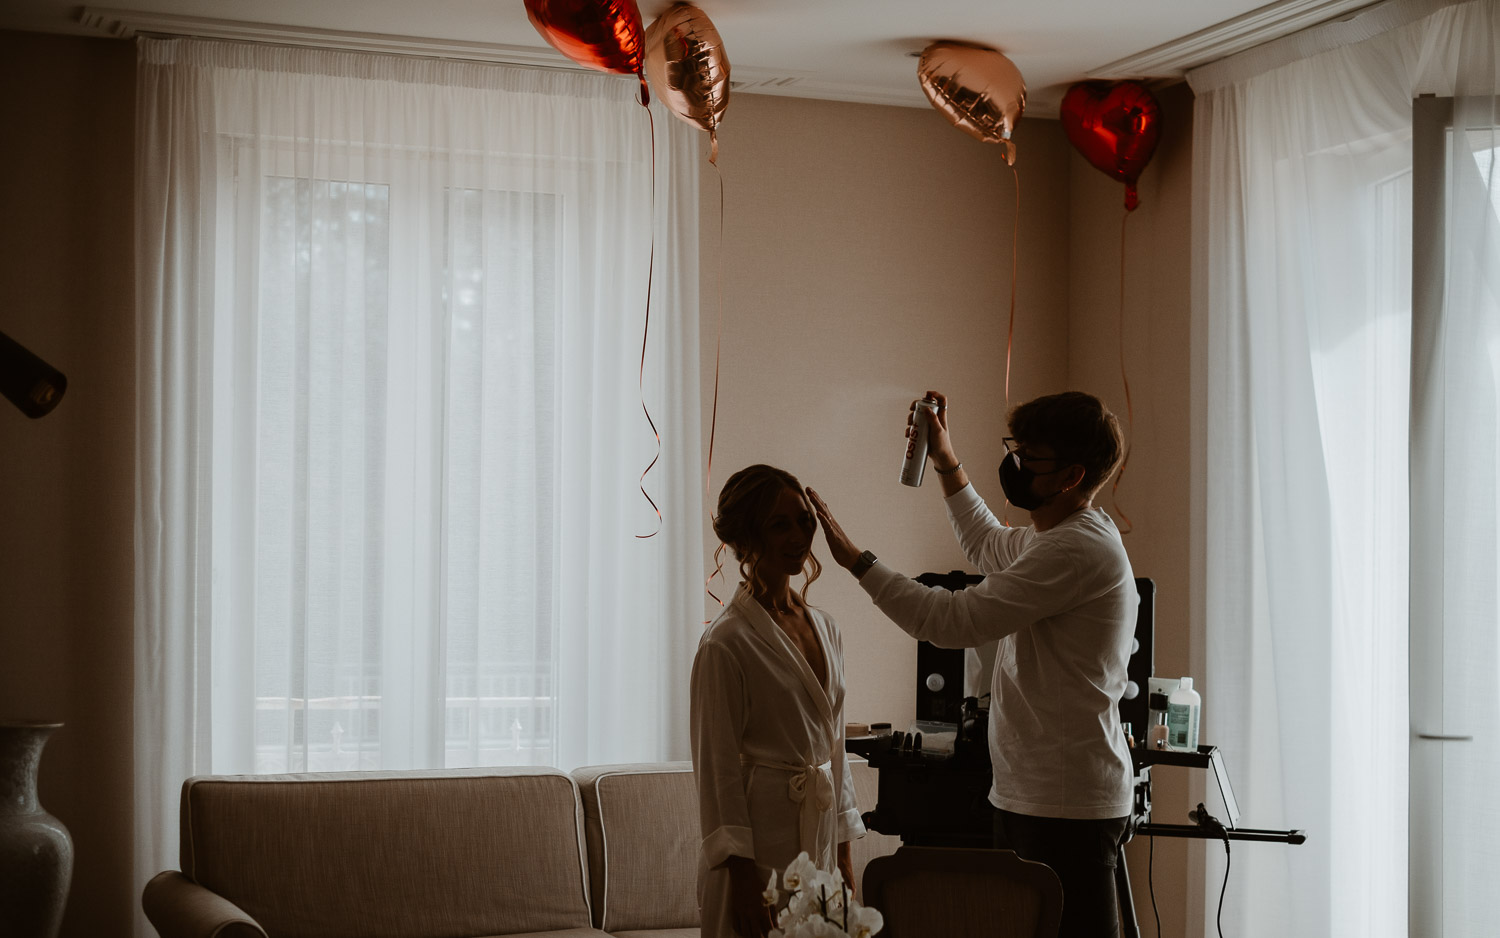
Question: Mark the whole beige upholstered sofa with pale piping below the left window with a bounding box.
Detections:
[143,759,900,938]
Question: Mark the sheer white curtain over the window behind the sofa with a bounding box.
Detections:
[135,34,704,924]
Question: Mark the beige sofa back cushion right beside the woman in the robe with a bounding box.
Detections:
[573,762,702,935]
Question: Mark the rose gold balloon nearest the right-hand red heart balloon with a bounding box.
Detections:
[917,42,1026,165]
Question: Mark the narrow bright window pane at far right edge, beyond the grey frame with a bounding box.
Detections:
[1410,91,1500,935]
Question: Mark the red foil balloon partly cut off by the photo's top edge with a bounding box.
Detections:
[525,0,651,104]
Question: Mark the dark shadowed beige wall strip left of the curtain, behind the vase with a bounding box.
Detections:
[0,32,135,936]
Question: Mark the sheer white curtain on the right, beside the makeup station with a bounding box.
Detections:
[1190,0,1500,938]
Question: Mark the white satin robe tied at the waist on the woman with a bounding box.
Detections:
[692,584,864,938]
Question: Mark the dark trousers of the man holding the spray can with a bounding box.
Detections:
[995,810,1130,938]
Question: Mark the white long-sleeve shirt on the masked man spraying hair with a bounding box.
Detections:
[860,486,1140,819]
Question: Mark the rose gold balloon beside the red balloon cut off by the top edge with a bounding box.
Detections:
[647,3,729,164]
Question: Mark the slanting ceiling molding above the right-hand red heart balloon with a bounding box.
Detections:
[1088,0,1376,80]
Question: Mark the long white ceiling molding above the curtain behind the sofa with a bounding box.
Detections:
[78,6,584,71]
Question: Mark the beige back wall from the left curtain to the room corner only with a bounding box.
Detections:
[699,95,1070,728]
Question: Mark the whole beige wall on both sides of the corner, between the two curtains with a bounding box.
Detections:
[717,86,1202,933]
